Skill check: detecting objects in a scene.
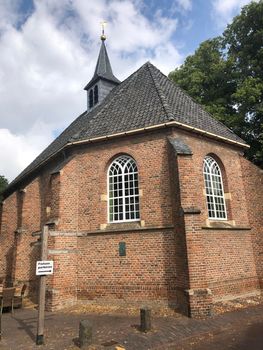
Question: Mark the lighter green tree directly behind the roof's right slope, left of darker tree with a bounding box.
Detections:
[169,37,236,126]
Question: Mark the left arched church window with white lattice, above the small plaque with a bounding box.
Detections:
[108,155,140,222]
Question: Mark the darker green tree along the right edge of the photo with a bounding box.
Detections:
[223,0,263,166]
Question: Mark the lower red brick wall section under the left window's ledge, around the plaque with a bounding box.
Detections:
[78,230,176,304]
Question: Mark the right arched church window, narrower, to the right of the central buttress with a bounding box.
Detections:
[203,156,227,220]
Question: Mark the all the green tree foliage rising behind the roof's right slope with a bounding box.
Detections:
[169,0,263,167]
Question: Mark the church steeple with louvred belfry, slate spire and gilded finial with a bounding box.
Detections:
[84,25,120,111]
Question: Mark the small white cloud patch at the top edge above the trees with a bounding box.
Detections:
[212,0,257,27]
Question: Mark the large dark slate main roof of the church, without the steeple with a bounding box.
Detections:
[6,62,245,196]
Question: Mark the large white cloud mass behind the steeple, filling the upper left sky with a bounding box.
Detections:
[0,0,184,180]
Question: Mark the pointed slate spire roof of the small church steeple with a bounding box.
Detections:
[84,40,120,90]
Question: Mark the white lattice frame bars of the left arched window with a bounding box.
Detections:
[107,154,140,223]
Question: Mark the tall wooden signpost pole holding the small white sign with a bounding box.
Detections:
[36,225,48,345]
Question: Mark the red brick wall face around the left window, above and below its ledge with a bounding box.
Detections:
[51,134,176,303]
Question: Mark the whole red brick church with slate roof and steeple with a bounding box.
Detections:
[0,36,263,317]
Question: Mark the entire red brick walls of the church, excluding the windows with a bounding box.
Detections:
[0,130,262,314]
